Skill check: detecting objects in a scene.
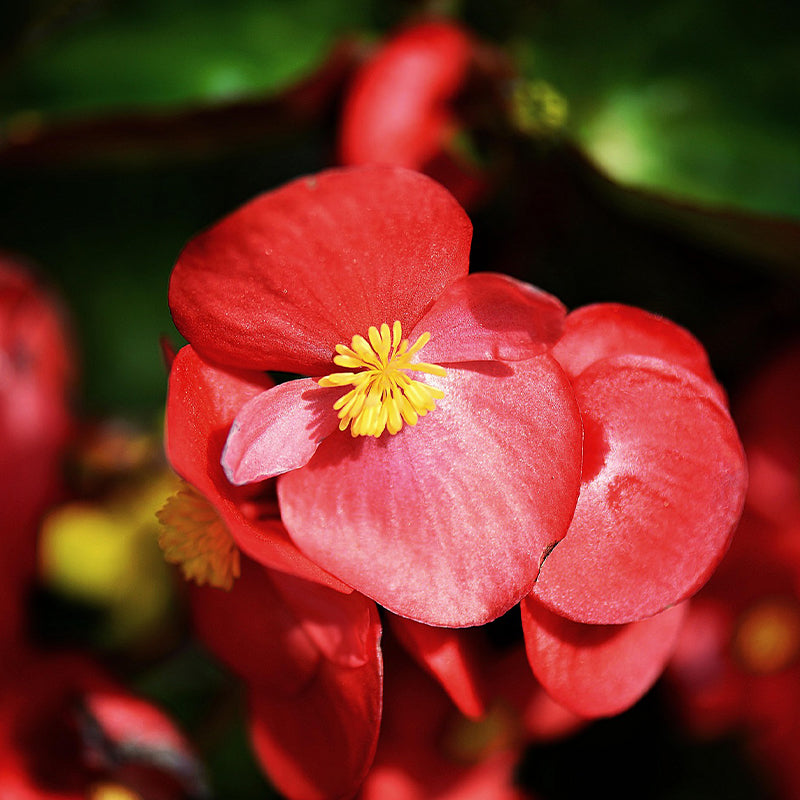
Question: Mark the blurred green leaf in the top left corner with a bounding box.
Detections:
[0,0,369,124]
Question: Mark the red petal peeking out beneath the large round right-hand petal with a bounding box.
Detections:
[521,597,686,717]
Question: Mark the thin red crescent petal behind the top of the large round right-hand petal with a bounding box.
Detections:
[553,303,725,400]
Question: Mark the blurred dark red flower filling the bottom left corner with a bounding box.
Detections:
[0,651,207,800]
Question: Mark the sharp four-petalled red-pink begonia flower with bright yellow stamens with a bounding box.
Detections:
[170,166,581,626]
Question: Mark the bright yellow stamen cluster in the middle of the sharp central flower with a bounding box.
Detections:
[319,321,447,438]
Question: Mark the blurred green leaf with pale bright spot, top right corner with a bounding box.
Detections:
[500,0,800,215]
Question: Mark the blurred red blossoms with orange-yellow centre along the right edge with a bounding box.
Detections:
[669,345,800,800]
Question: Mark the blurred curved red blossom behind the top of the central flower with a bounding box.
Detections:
[339,20,483,204]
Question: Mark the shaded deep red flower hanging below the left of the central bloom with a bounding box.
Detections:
[193,559,383,800]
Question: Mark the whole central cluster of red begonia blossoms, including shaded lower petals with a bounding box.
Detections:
[162,165,746,798]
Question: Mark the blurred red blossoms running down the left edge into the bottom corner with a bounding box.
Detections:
[0,257,206,800]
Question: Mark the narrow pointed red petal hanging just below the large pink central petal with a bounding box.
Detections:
[389,614,486,717]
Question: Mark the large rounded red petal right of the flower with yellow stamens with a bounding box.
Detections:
[534,356,747,624]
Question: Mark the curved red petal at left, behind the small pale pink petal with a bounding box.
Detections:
[165,346,350,592]
